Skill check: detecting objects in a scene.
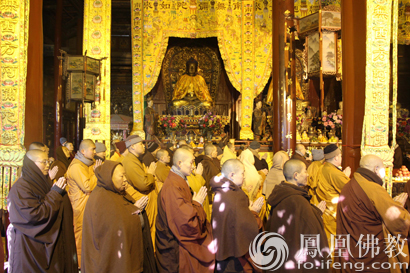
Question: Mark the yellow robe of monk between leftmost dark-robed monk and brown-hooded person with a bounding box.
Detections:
[66,158,97,265]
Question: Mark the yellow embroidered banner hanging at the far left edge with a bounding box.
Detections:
[0,0,30,210]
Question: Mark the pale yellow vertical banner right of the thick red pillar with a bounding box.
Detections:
[361,0,394,193]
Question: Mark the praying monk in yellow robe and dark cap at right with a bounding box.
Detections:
[316,144,351,251]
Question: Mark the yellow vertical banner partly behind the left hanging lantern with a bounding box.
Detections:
[83,0,111,153]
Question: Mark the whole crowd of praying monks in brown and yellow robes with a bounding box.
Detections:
[3,135,410,273]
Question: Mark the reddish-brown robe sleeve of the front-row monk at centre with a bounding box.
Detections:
[163,187,207,240]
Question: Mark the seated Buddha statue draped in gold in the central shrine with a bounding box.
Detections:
[172,58,213,108]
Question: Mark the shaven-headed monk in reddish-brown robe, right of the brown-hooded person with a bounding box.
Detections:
[155,149,215,273]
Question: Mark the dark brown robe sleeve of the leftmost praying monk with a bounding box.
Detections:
[9,184,63,243]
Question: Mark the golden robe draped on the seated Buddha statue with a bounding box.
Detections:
[172,75,212,103]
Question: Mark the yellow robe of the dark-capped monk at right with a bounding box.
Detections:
[316,162,350,251]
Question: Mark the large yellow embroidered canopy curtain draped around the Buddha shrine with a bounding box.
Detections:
[131,0,272,96]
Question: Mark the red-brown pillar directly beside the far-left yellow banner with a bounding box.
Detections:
[24,0,43,148]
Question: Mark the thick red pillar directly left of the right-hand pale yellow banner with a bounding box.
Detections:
[342,1,366,172]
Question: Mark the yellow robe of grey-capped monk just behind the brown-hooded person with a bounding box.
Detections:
[122,153,158,242]
